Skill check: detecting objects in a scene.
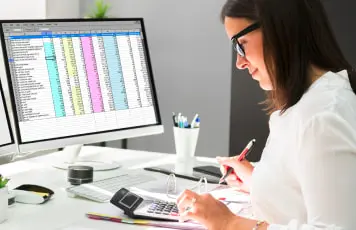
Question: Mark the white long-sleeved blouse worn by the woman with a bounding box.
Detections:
[251,71,356,230]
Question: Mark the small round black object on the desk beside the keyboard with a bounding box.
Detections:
[68,165,94,185]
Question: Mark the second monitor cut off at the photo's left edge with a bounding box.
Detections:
[0,81,17,157]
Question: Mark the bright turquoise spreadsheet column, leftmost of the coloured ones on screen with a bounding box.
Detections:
[43,38,66,117]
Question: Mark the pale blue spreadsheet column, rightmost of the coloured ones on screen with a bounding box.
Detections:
[103,35,129,110]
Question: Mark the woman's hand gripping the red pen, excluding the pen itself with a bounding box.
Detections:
[216,156,254,193]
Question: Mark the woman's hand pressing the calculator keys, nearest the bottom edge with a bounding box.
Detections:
[177,190,237,229]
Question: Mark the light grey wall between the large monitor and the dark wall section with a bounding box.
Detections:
[81,0,231,156]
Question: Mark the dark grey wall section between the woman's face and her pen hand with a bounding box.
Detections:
[230,58,269,161]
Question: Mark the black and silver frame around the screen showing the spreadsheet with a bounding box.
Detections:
[0,17,163,147]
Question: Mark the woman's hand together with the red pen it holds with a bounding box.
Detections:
[217,139,256,190]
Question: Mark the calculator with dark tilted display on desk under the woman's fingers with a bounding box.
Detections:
[110,188,179,221]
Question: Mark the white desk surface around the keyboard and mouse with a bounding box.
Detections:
[0,146,215,230]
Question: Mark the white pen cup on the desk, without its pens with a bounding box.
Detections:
[173,127,199,175]
